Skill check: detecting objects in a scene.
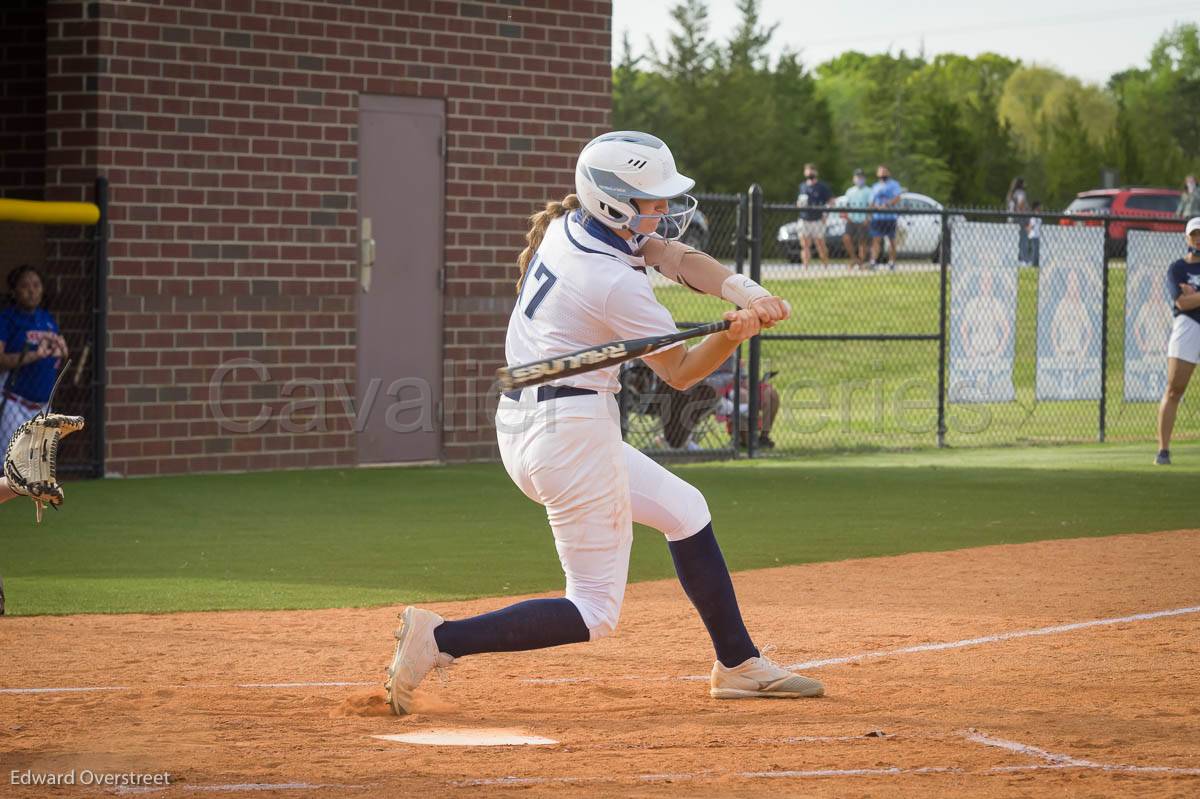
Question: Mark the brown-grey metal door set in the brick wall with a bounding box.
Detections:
[355,95,445,463]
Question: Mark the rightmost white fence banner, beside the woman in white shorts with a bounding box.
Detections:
[1124,230,1182,402]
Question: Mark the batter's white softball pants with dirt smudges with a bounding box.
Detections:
[496,389,712,641]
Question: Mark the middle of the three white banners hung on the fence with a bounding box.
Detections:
[1037,226,1105,401]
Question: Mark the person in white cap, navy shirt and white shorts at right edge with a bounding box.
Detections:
[1154,216,1200,465]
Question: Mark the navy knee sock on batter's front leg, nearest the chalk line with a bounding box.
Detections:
[670,523,758,668]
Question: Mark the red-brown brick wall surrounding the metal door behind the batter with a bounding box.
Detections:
[47,0,611,475]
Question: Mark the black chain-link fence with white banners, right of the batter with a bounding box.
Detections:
[623,184,1200,457]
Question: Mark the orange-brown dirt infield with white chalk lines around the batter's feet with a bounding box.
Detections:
[0,530,1200,797]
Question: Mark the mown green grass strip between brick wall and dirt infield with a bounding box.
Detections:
[0,445,1200,614]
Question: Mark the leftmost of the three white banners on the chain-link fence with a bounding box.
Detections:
[949,221,1018,402]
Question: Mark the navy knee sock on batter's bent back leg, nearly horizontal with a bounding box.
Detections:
[433,599,590,657]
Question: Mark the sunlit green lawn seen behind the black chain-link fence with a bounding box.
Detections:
[656,261,1200,451]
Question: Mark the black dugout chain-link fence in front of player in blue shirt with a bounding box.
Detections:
[0,181,107,476]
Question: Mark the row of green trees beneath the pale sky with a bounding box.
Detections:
[613,0,1200,209]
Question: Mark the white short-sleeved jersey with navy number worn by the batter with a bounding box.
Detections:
[504,211,683,394]
